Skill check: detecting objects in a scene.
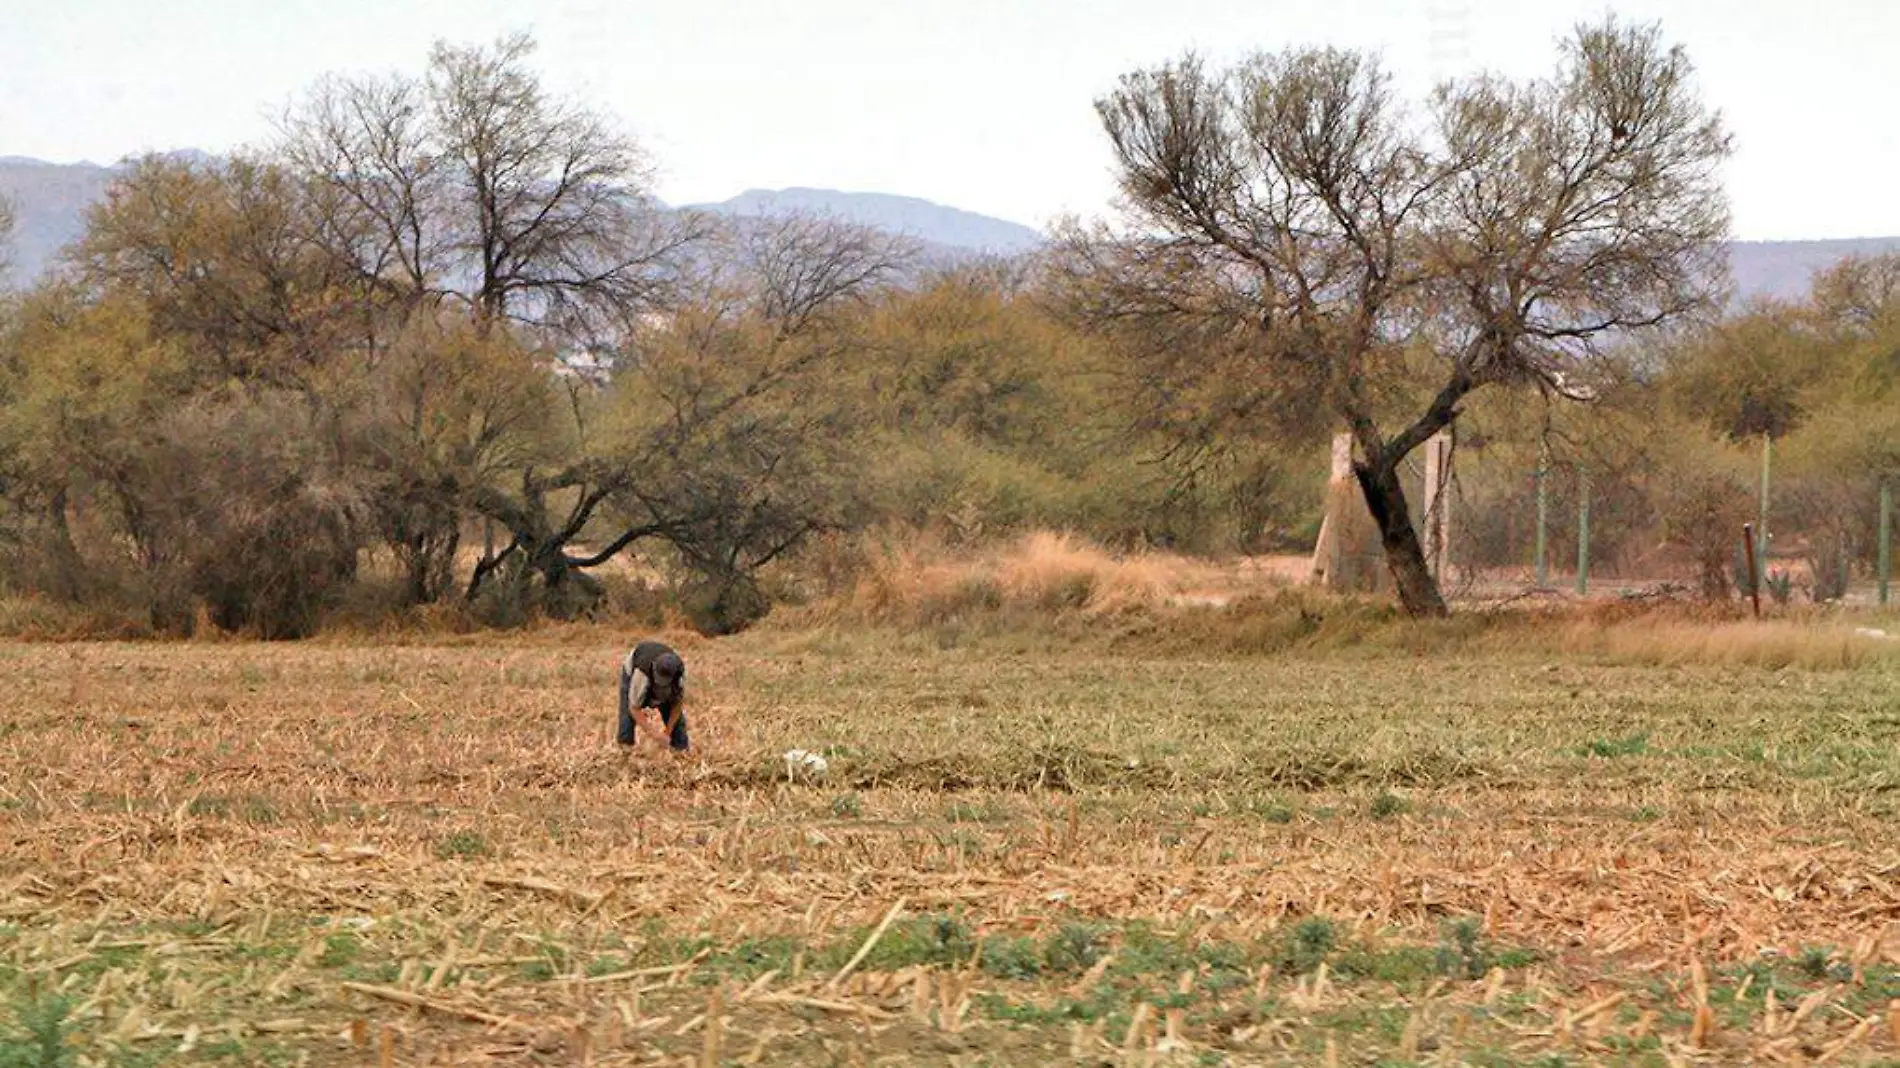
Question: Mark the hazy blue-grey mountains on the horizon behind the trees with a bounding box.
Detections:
[0,150,1900,300]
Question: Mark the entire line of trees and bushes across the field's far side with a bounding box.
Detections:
[0,23,1900,637]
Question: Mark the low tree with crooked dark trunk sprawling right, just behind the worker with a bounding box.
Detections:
[456,209,906,620]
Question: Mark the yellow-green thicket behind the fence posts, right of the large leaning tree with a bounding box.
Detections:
[1436,255,1900,601]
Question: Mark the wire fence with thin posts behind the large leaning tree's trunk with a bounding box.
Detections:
[1313,427,1894,604]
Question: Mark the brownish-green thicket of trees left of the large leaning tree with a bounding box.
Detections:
[0,38,1322,637]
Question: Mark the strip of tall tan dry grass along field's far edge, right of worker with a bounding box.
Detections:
[781,532,1900,671]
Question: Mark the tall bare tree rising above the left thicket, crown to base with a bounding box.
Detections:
[281,34,709,597]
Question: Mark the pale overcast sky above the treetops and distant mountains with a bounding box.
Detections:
[0,0,1900,239]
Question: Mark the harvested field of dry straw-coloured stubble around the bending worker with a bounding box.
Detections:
[0,627,1900,1066]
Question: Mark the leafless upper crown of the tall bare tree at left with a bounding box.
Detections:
[281,34,705,344]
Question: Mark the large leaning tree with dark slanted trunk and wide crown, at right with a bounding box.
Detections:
[1058,21,1729,614]
